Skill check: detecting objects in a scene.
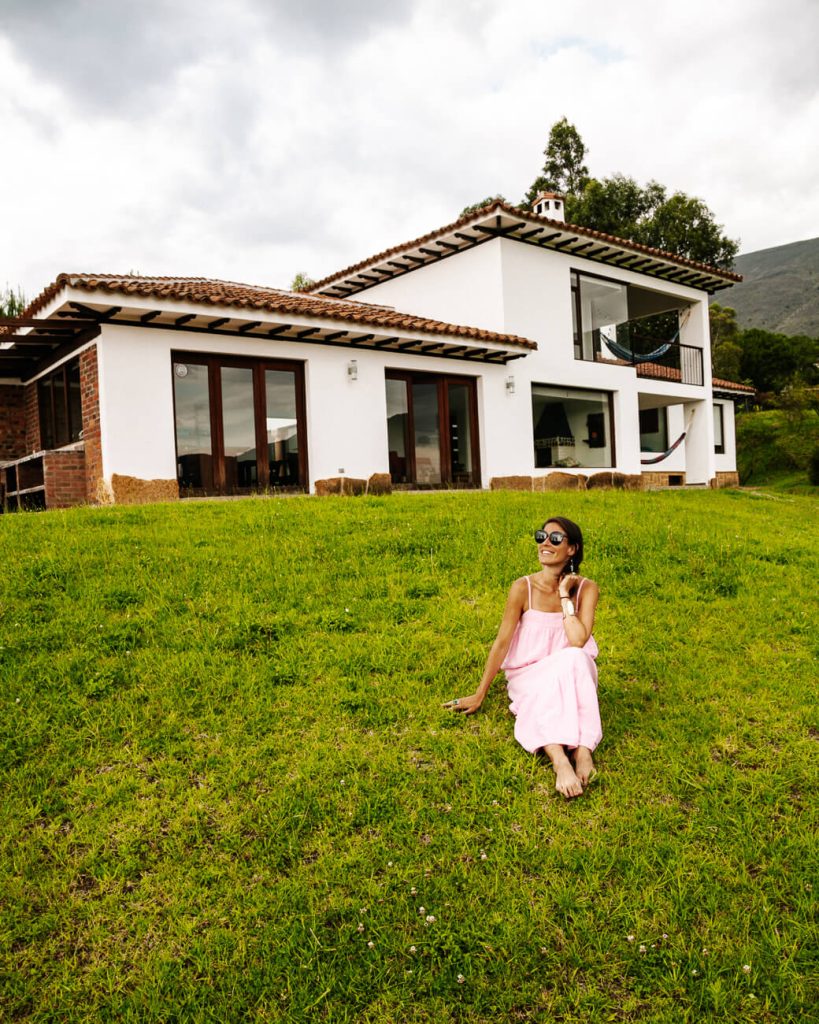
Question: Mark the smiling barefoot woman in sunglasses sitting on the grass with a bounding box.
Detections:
[444,516,603,798]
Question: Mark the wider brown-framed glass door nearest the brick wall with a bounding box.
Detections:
[172,352,307,495]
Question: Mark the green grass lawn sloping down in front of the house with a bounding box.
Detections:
[0,492,819,1024]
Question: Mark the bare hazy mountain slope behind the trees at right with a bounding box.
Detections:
[714,239,819,338]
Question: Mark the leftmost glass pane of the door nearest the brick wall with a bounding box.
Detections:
[173,362,213,490]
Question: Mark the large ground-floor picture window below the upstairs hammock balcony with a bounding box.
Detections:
[531,384,614,469]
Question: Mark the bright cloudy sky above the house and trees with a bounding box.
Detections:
[0,0,819,299]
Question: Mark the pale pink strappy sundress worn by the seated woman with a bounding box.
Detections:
[501,577,603,754]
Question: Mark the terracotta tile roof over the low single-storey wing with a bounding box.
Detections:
[24,273,537,349]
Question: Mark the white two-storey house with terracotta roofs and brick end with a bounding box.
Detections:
[0,194,751,508]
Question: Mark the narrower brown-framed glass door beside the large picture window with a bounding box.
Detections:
[386,370,480,487]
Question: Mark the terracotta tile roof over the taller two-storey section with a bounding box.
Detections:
[310,200,742,292]
